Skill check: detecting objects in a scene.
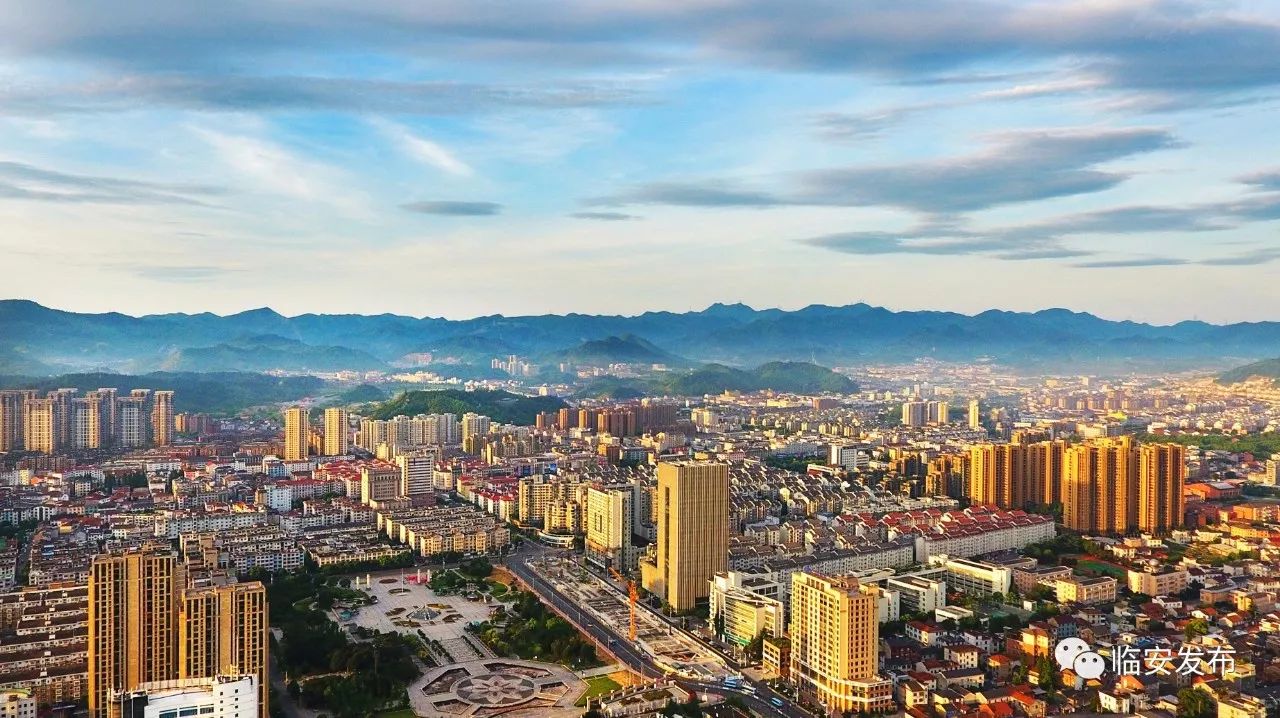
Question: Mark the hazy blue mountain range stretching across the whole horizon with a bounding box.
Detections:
[0,299,1280,375]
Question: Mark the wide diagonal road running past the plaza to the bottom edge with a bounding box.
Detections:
[507,552,813,718]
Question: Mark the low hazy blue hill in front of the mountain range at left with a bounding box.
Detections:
[160,334,385,371]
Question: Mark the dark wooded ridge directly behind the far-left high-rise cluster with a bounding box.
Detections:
[0,371,324,415]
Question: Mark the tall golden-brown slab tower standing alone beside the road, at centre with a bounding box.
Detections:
[645,461,728,610]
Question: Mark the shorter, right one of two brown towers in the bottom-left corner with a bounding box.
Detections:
[178,581,270,715]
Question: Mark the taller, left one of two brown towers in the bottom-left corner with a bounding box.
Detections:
[88,548,182,718]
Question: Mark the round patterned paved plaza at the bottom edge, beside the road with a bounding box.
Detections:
[408,658,586,718]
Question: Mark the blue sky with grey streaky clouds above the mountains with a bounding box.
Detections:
[0,0,1280,323]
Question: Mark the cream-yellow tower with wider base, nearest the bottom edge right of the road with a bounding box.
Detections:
[790,572,892,714]
